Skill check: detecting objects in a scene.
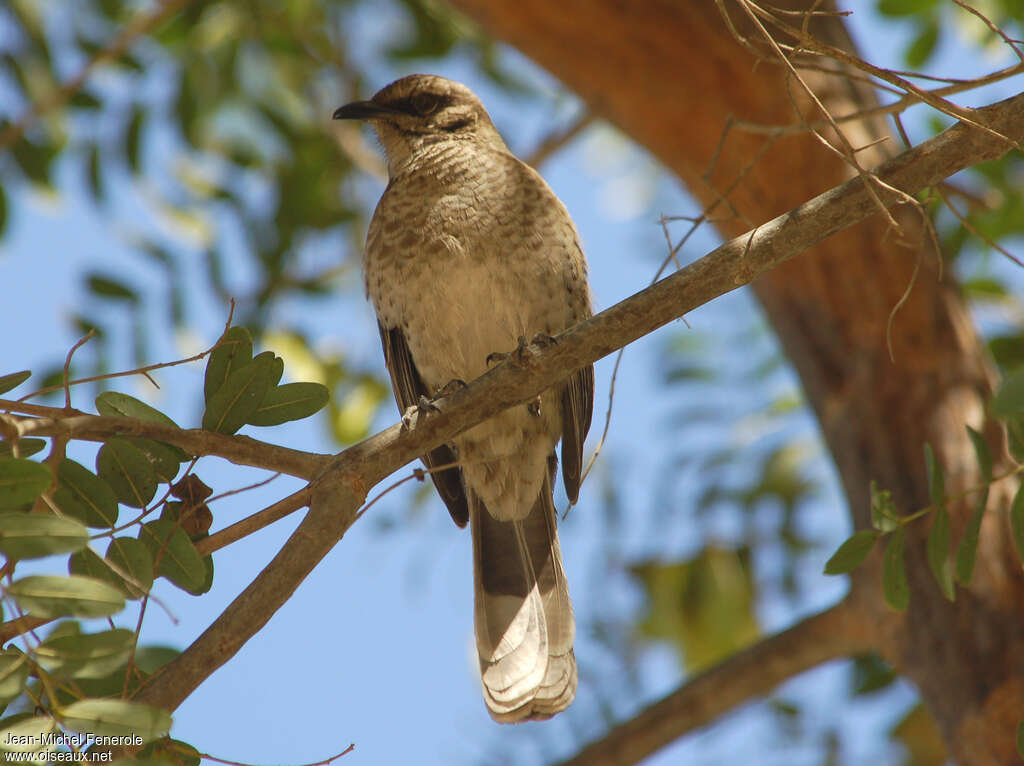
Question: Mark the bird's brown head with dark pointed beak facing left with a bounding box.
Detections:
[334,75,505,174]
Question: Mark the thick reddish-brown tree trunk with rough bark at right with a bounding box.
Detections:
[454,0,1024,765]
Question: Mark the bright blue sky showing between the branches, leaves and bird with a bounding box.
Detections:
[0,3,1020,764]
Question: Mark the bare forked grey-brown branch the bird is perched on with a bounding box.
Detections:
[8,94,1024,729]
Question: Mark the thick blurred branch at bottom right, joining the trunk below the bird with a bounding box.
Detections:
[561,598,870,766]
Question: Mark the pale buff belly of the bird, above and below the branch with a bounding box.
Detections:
[379,236,568,520]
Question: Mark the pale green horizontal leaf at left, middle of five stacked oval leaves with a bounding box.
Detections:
[7,575,125,620]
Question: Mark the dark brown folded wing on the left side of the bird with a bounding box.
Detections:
[377,323,468,526]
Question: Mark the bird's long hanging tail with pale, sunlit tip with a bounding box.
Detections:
[469,466,577,723]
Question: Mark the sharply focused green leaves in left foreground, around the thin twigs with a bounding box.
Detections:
[0,327,328,764]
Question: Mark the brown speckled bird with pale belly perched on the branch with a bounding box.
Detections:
[334,75,594,723]
